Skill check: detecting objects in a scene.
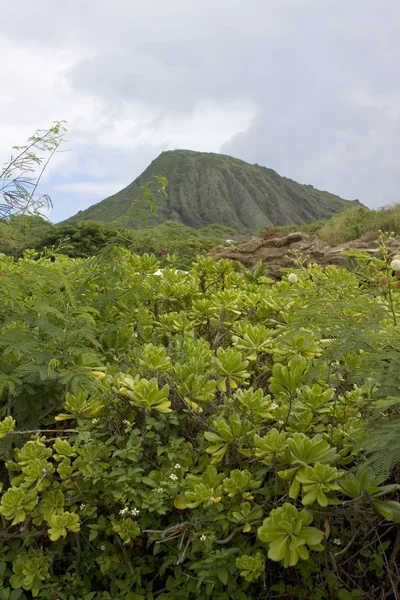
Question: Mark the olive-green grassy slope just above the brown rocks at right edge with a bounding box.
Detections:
[263,204,400,246]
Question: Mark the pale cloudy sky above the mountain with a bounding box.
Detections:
[0,0,400,222]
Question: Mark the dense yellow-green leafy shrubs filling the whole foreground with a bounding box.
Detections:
[0,236,400,600]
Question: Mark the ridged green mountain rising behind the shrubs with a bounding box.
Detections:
[69,150,359,232]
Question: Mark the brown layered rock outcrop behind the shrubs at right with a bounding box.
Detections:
[209,232,400,279]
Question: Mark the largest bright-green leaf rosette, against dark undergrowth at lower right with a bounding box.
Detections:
[257,503,324,568]
